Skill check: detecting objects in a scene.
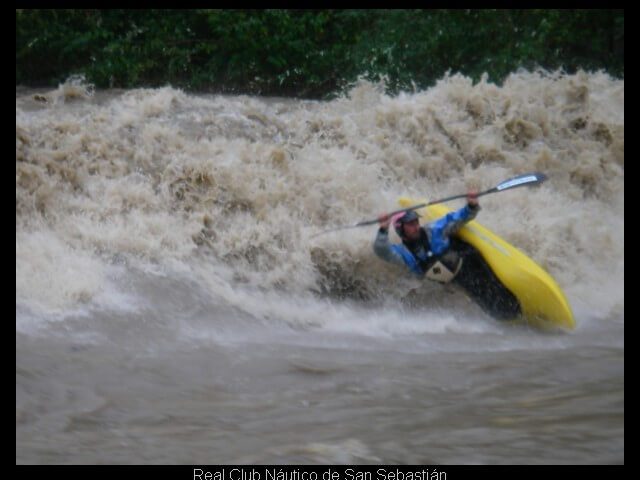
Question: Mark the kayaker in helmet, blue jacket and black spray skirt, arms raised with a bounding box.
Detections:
[373,191,521,320]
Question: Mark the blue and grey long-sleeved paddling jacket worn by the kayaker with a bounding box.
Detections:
[373,205,480,278]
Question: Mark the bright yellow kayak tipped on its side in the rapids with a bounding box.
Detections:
[398,197,575,330]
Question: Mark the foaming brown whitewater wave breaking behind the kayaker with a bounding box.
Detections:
[16,71,624,326]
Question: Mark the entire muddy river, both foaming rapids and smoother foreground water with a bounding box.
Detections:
[16,71,624,464]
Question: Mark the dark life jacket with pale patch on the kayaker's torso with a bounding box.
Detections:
[391,228,462,283]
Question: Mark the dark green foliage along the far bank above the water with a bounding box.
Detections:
[16,9,624,97]
